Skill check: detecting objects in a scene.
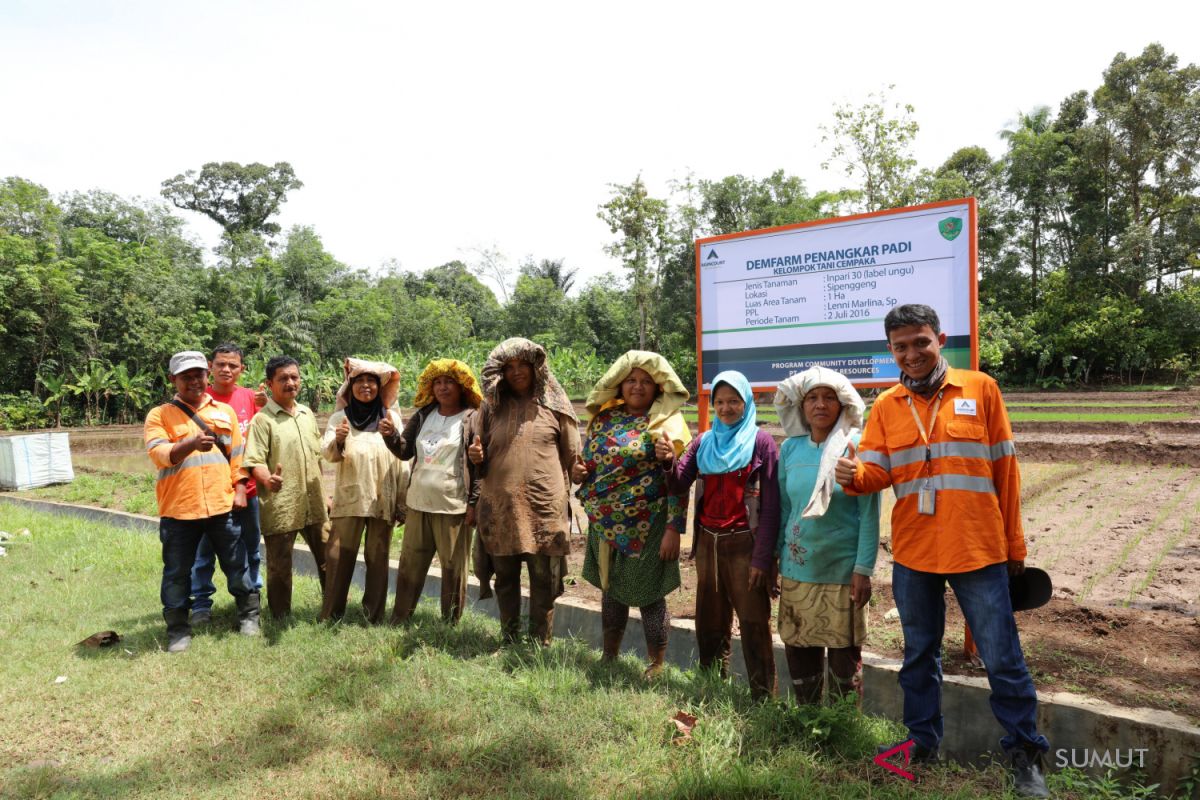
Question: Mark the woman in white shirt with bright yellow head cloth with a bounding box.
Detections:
[380,359,481,624]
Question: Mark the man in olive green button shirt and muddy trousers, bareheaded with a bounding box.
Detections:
[242,355,326,619]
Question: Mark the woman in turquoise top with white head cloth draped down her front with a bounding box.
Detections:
[775,367,880,704]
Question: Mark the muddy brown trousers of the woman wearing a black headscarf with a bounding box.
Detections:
[320,517,394,625]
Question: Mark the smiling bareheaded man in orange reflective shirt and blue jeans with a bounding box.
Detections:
[836,305,1050,798]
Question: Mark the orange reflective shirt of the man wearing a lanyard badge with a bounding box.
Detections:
[846,369,1025,573]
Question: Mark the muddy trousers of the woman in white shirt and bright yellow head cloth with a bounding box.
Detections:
[391,509,470,625]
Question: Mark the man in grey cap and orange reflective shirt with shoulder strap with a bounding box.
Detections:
[145,350,259,652]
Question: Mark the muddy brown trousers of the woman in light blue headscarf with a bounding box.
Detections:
[695,525,775,698]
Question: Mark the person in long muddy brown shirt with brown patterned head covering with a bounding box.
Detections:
[467,338,580,644]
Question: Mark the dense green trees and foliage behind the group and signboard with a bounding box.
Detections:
[0,44,1200,428]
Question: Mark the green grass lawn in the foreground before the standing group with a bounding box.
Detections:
[0,504,1113,800]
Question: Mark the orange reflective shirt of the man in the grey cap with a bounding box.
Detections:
[145,395,248,519]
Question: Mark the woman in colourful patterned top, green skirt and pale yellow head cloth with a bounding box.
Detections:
[571,350,691,676]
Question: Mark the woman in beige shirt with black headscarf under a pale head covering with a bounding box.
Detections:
[320,359,408,624]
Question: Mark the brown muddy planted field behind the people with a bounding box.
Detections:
[16,391,1200,722]
